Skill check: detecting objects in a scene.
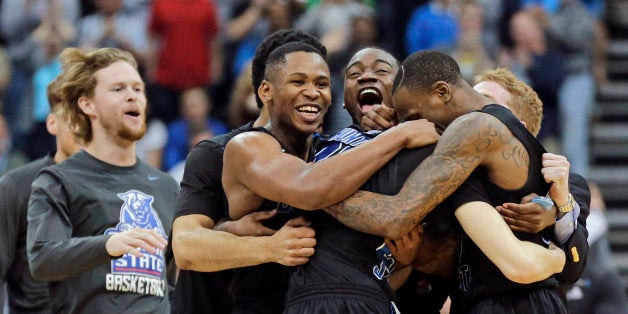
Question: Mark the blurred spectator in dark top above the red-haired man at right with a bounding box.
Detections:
[499,10,565,146]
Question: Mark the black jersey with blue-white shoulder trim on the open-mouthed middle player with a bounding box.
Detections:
[290,127,453,306]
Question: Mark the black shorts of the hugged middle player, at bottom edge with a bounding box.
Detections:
[284,283,391,314]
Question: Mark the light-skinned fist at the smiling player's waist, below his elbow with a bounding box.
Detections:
[269,217,316,266]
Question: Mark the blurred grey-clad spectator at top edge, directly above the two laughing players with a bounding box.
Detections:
[295,0,370,55]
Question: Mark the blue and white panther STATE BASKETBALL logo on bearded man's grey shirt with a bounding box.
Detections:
[105,190,166,296]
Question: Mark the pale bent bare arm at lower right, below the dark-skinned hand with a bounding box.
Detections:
[456,202,565,284]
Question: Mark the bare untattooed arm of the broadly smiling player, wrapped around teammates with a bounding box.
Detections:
[223,120,438,219]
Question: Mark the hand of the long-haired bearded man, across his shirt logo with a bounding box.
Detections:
[105,228,168,257]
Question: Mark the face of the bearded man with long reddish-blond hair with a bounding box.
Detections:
[86,61,146,142]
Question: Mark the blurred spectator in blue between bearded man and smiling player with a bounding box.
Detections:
[162,87,229,171]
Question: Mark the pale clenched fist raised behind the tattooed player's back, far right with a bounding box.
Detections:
[541,153,569,206]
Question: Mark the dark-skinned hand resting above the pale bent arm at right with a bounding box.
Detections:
[497,193,556,233]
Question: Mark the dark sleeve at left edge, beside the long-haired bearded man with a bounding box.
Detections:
[0,175,20,286]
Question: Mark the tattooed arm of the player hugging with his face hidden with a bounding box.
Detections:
[325,112,512,239]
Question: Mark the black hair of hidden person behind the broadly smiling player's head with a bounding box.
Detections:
[251,29,327,109]
